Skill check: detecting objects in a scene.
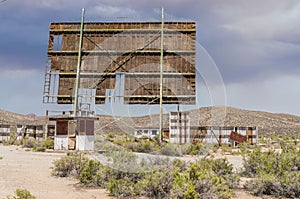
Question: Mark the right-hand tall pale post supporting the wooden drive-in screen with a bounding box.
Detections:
[159,7,164,143]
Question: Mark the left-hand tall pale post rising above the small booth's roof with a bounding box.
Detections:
[74,8,84,117]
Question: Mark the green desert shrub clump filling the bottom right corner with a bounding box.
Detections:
[244,144,300,198]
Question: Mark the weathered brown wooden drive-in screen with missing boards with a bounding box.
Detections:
[44,22,196,104]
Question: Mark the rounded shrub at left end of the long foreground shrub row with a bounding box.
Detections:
[52,152,88,177]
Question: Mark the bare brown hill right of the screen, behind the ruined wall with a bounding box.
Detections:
[190,107,300,134]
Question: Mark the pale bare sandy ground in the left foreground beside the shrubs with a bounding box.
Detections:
[0,145,110,199]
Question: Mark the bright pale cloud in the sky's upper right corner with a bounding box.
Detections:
[222,1,300,42]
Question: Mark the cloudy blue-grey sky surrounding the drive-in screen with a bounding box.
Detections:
[0,0,300,115]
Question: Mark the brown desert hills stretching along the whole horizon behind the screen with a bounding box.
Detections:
[0,106,300,134]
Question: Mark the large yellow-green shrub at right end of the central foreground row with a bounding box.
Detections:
[139,159,237,199]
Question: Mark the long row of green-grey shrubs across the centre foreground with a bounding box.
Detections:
[53,151,238,199]
